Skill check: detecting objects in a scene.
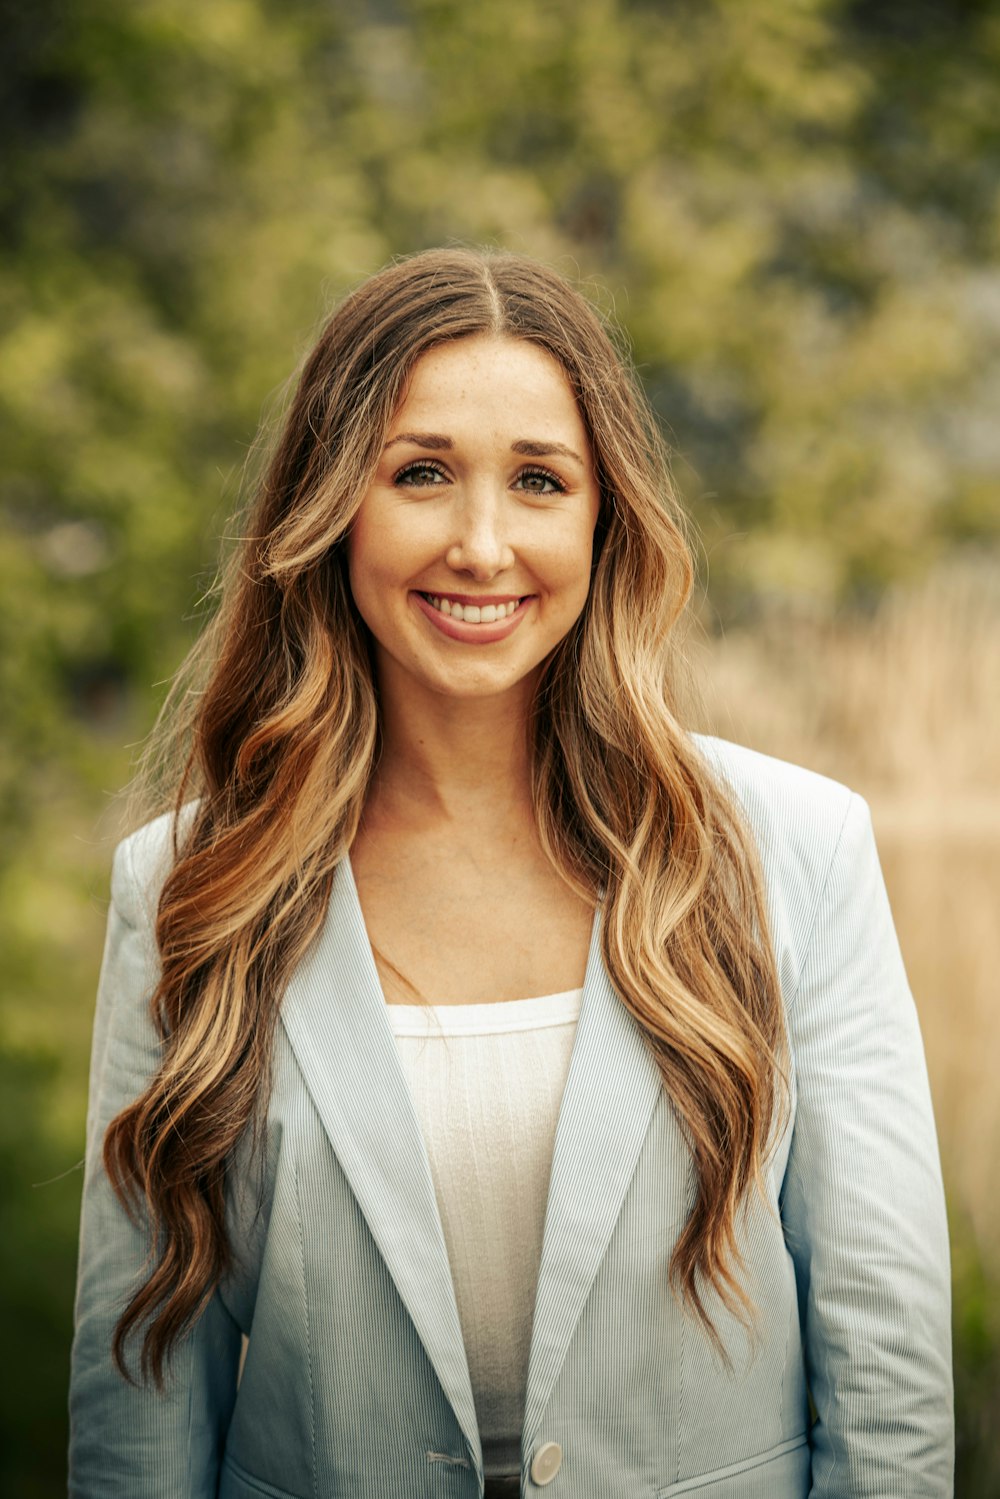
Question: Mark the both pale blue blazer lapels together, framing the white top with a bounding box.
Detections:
[282,857,661,1474]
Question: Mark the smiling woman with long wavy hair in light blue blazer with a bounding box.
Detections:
[70,250,952,1499]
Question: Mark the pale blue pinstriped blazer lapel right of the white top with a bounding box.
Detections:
[522,905,663,1453]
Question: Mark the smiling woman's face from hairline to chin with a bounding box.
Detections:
[348,334,600,710]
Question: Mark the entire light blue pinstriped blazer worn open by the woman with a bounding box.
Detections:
[70,739,952,1499]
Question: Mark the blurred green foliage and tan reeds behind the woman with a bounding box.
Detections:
[0,0,1000,1499]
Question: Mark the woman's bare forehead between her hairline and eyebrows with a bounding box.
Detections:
[393,334,585,441]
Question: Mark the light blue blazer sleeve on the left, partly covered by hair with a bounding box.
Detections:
[69,842,240,1499]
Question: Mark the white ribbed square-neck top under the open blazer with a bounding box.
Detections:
[387,989,583,1478]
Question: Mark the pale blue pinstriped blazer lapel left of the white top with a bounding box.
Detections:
[282,857,483,1472]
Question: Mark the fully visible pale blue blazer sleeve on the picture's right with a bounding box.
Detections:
[781,796,954,1499]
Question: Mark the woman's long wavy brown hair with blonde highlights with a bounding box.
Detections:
[103,249,784,1384]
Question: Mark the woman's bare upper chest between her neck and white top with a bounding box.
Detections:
[351,839,594,1004]
